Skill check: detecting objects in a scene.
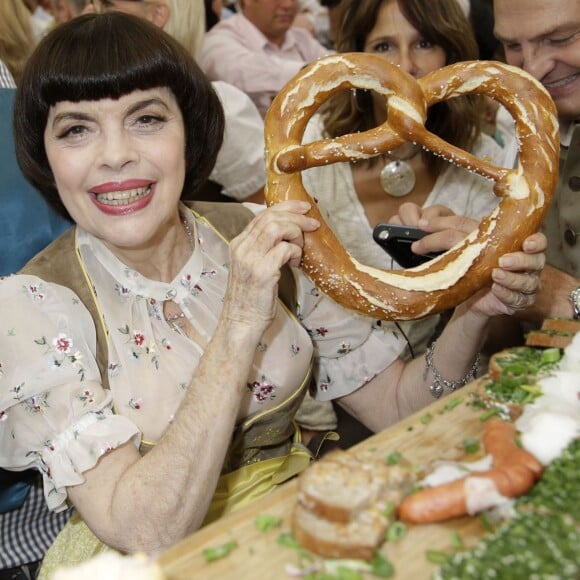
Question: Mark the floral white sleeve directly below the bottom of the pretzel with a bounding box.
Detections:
[295,270,405,401]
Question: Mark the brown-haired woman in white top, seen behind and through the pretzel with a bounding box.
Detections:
[304,0,503,358]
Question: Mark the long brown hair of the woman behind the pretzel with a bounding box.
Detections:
[323,0,482,170]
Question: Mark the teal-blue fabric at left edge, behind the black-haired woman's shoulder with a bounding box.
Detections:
[0,89,71,276]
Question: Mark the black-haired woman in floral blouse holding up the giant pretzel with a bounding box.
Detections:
[0,12,545,578]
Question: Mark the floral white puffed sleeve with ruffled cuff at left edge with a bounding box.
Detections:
[0,275,140,511]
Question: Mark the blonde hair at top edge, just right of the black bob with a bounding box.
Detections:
[163,0,205,58]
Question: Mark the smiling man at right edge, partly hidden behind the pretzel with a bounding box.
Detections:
[494,0,580,322]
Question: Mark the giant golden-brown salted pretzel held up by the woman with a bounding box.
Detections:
[265,53,559,320]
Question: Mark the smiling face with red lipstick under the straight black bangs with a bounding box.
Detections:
[44,88,185,249]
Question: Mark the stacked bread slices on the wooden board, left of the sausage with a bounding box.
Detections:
[292,450,417,560]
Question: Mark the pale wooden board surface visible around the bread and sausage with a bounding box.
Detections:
[159,378,494,580]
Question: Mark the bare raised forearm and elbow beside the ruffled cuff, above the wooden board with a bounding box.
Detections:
[69,322,264,551]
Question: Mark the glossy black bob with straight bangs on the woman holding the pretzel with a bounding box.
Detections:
[13,12,224,215]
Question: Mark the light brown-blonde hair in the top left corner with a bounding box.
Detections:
[0,0,36,85]
